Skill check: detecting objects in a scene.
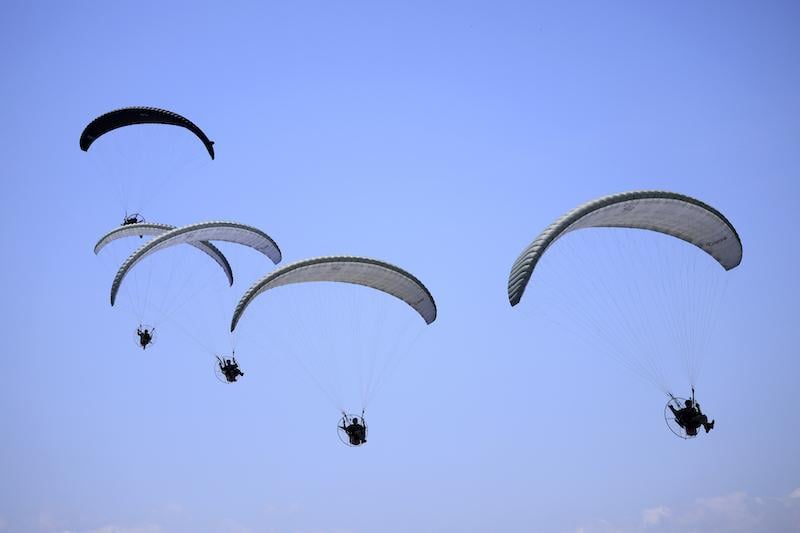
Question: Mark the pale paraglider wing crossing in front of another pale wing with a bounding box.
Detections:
[111,222,281,305]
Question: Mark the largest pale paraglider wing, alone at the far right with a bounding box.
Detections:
[508,191,742,305]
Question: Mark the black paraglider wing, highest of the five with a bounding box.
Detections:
[80,107,214,159]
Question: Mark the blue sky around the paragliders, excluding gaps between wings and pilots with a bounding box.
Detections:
[0,1,800,533]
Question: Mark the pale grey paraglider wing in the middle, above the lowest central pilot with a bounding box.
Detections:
[231,256,436,331]
